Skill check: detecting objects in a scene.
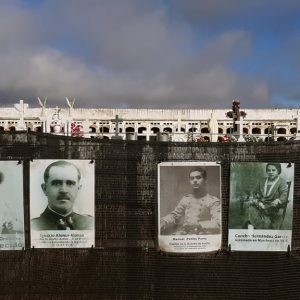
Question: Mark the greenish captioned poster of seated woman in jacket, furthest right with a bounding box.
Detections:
[228,162,294,251]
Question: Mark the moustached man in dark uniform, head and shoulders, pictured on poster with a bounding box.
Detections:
[31,160,94,231]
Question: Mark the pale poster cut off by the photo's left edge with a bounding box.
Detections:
[0,161,25,250]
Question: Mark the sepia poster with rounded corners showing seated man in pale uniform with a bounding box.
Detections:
[158,162,222,252]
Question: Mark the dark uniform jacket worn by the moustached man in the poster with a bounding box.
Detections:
[31,207,94,230]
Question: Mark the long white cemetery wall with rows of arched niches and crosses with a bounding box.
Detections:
[0,100,300,141]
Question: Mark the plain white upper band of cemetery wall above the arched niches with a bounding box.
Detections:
[0,107,299,121]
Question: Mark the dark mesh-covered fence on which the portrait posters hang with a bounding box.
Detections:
[0,133,300,299]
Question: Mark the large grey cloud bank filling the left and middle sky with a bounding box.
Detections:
[0,0,274,107]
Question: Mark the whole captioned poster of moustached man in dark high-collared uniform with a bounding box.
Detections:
[30,160,95,248]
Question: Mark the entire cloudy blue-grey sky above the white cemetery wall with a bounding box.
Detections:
[0,0,300,108]
